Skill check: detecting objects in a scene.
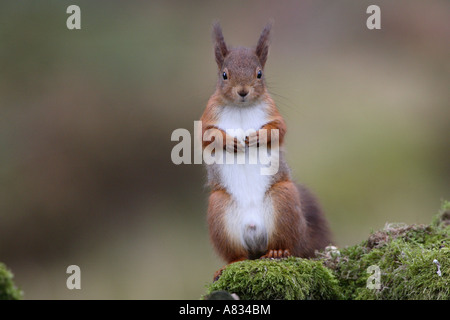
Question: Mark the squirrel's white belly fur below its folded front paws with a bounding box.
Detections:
[218,163,274,257]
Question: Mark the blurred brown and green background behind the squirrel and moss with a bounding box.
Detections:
[0,0,450,299]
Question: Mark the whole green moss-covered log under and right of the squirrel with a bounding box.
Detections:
[203,201,450,300]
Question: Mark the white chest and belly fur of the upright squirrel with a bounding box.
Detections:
[217,105,273,252]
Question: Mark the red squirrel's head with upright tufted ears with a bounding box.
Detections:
[213,22,272,106]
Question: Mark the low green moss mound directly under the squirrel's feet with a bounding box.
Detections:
[208,258,341,300]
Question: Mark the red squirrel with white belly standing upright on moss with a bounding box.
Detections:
[200,22,331,280]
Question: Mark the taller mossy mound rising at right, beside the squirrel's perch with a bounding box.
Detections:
[324,202,450,300]
